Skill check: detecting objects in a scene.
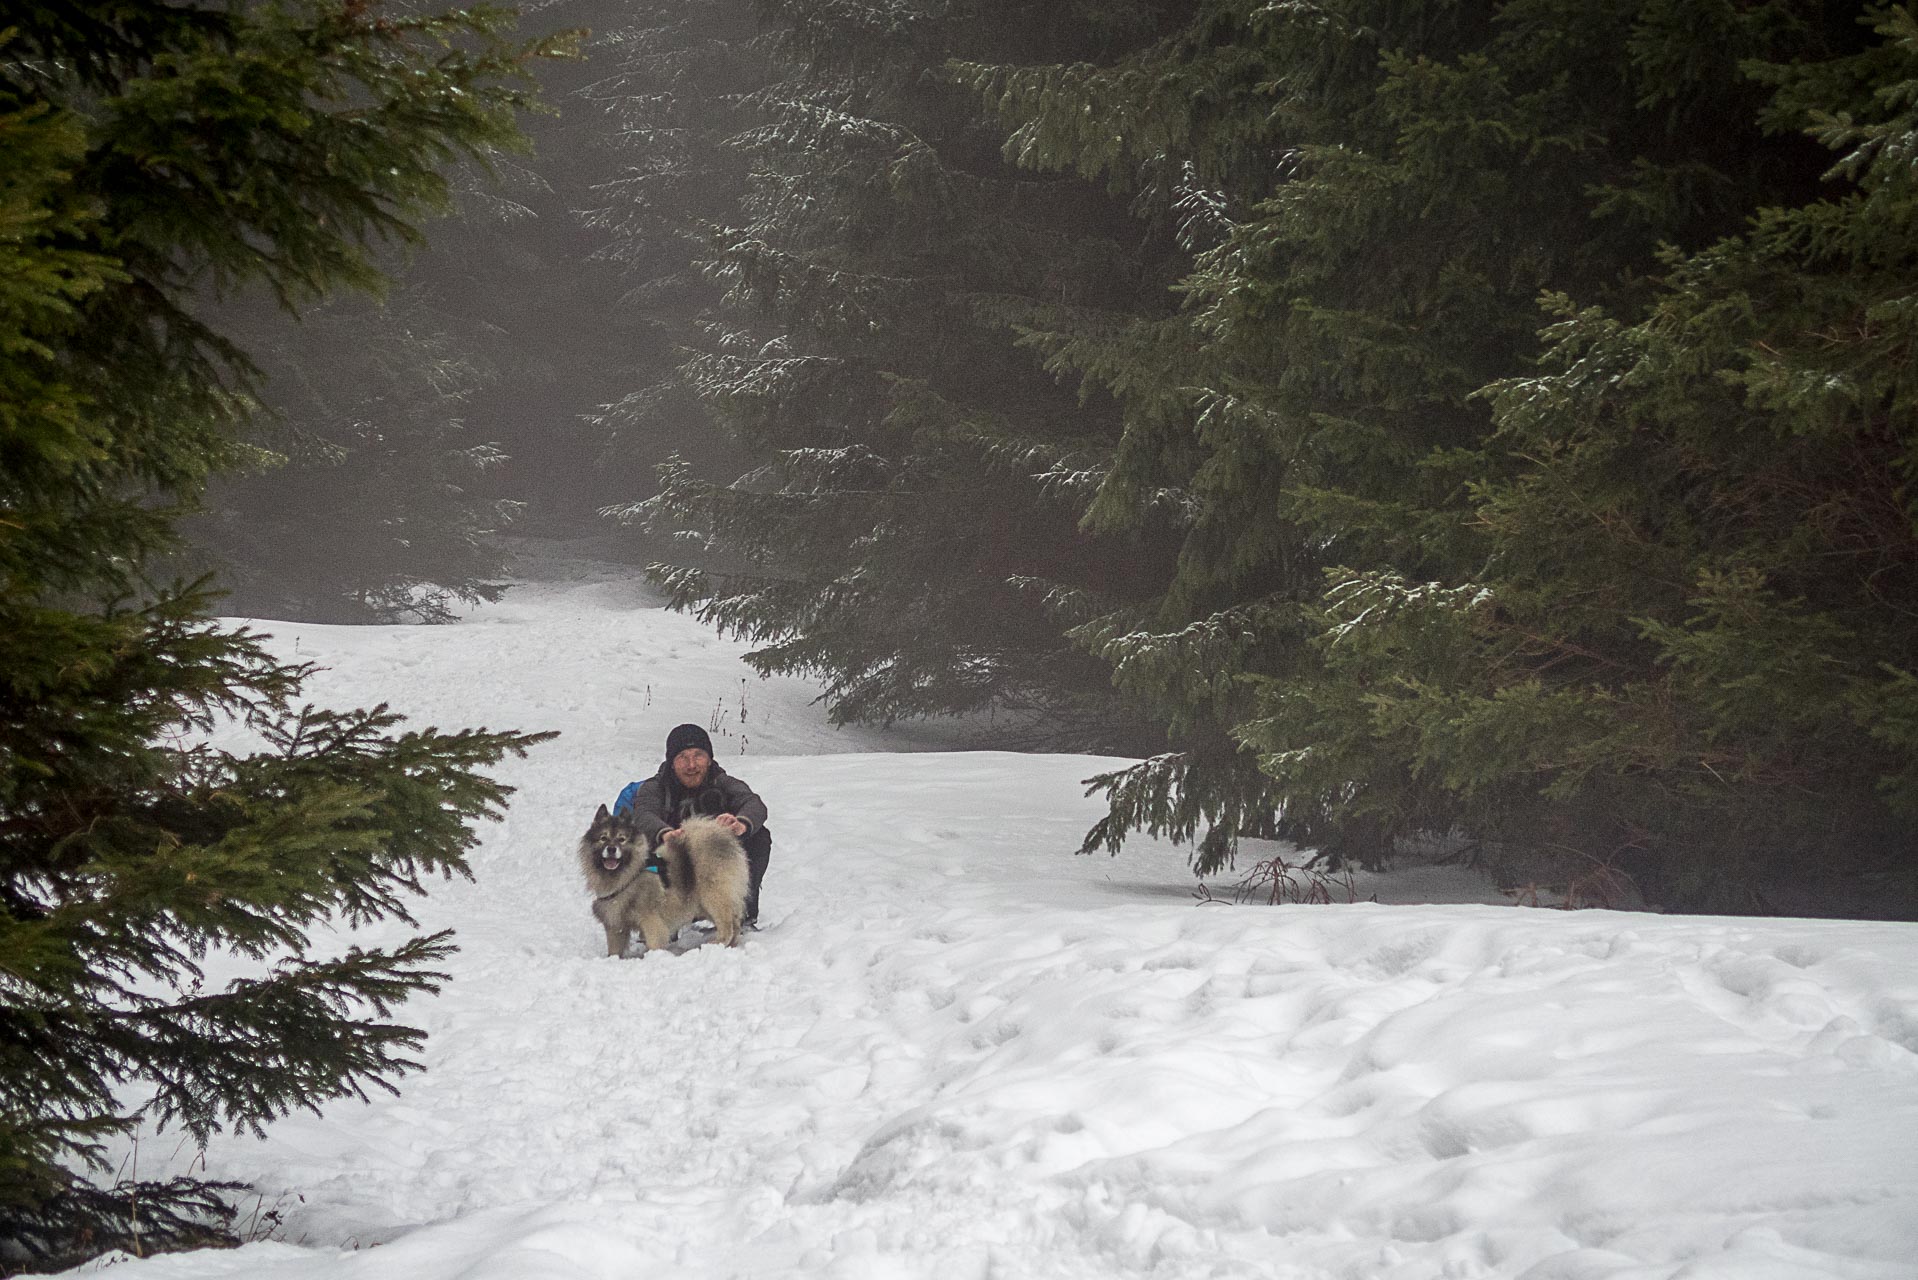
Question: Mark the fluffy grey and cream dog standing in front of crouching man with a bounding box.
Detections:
[579,804,752,956]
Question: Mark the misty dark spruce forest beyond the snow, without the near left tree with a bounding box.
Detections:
[183,0,1918,913]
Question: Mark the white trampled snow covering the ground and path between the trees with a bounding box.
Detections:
[70,551,1918,1280]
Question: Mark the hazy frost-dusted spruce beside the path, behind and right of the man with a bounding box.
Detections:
[590,0,1170,747]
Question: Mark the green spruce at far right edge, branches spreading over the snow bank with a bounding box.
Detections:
[1260,10,1918,915]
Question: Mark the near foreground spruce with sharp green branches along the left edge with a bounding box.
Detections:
[0,0,554,1270]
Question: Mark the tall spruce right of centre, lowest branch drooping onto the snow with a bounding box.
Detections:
[963,0,1894,900]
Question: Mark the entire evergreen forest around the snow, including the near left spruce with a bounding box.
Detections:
[0,0,1918,1272]
